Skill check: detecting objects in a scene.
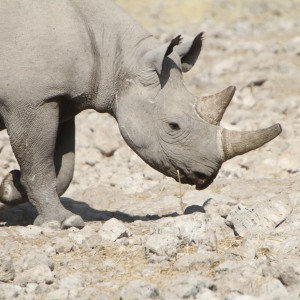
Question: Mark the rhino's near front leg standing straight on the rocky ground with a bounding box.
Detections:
[7,101,84,228]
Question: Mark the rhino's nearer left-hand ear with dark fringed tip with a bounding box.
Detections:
[142,35,182,74]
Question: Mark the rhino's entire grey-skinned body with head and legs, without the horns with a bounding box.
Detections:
[0,0,279,228]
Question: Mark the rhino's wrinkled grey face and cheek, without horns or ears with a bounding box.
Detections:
[117,53,222,188]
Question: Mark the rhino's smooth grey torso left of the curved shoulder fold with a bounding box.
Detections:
[0,0,93,102]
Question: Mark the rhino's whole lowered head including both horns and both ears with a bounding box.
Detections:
[116,33,281,189]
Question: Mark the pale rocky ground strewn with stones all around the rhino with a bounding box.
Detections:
[0,0,300,300]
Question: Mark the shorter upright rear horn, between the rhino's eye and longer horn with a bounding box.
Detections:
[196,86,235,125]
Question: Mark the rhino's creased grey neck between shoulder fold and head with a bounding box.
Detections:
[72,0,157,115]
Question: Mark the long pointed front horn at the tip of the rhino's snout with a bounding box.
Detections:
[222,124,282,161]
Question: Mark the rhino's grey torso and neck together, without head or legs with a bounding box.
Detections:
[0,0,149,111]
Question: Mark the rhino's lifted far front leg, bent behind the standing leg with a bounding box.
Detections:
[0,118,75,211]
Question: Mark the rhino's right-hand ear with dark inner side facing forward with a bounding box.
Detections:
[174,32,203,72]
